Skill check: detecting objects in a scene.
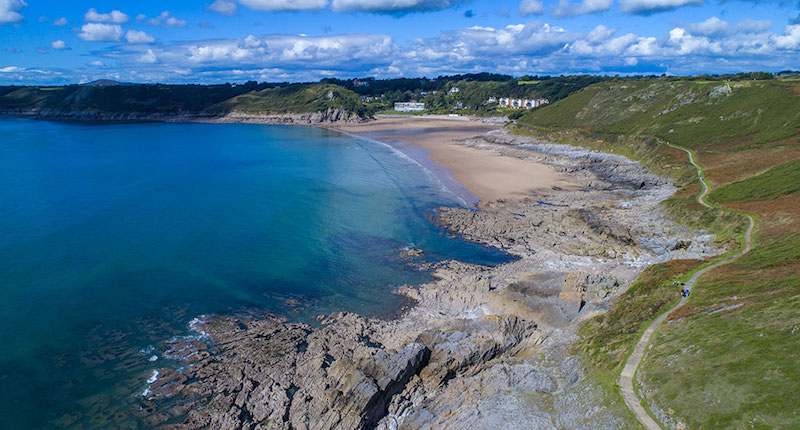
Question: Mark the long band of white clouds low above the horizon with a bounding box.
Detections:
[15,19,800,82]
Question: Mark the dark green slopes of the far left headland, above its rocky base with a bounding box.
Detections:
[0,84,366,115]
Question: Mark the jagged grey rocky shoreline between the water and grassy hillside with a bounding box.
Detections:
[138,131,722,429]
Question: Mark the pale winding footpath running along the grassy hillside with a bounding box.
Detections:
[617,143,755,430]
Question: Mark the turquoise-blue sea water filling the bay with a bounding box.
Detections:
[0,119,507,428]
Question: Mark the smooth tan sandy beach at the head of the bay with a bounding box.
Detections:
[328,117,575,205]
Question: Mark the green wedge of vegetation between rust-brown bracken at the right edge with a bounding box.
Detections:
[711,160,800,203]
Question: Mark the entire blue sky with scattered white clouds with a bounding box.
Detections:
[0,0,800,84]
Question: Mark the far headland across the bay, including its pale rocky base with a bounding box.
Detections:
[0,84,369,125]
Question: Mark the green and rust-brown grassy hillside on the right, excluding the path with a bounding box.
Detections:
[516,79,800,428]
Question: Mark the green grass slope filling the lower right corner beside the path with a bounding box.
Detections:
[642,234,800,428]
